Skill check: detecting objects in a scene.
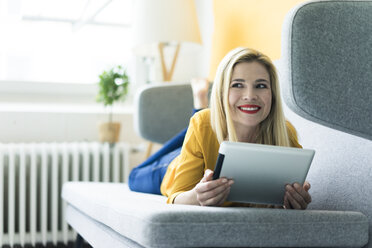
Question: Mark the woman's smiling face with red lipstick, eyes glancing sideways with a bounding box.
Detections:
[229,61,272,131]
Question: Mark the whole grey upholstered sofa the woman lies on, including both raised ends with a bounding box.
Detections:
[62,1,372,247]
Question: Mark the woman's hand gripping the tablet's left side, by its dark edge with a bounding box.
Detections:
[193,169,234,206]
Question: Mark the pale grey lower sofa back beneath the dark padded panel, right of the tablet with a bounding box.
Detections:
[285,103,372,247]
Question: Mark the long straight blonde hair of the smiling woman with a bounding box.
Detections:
[210,47,290,146]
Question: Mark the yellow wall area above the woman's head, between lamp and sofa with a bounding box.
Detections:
[209,0,305,80]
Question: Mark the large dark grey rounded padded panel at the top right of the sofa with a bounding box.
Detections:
[282,0,372,140]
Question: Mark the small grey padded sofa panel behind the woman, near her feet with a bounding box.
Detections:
[134,83,193,143]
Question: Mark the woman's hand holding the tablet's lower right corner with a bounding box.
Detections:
[284,182,311,209]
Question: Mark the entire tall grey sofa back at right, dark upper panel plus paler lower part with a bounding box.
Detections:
[279,0,372,247]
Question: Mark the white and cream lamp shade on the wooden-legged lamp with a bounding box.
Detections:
[133,0,201,47]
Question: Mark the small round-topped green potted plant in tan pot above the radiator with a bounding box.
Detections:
[96,65,129,143]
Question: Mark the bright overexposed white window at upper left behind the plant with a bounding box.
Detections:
[0,0,135,84]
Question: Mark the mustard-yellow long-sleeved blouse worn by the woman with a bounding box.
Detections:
[160,109,301,203]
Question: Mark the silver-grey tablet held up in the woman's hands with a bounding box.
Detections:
[213,141,315,205]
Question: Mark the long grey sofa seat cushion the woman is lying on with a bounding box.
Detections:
[62,182,368,247]
